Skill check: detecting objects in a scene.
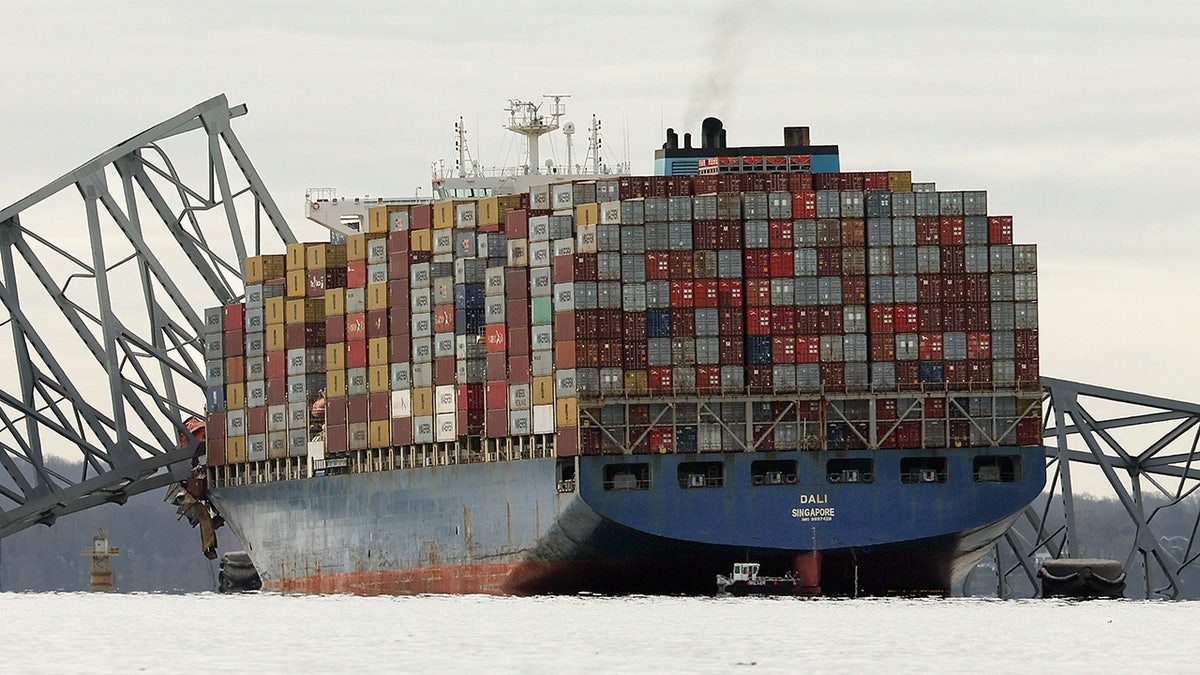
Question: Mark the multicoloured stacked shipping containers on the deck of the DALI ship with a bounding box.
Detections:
[206,172,1039,464]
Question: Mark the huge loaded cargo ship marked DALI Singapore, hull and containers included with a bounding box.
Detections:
[200,100,1045,596]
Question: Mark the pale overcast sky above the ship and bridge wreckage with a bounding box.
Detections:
[0,0,1200,480]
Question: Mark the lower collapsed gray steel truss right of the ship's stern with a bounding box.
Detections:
[995,377,1200,598]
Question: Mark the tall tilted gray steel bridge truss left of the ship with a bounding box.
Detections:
[0,95,295,537]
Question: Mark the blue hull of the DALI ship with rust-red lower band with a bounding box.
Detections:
[210,447,1044,596]
